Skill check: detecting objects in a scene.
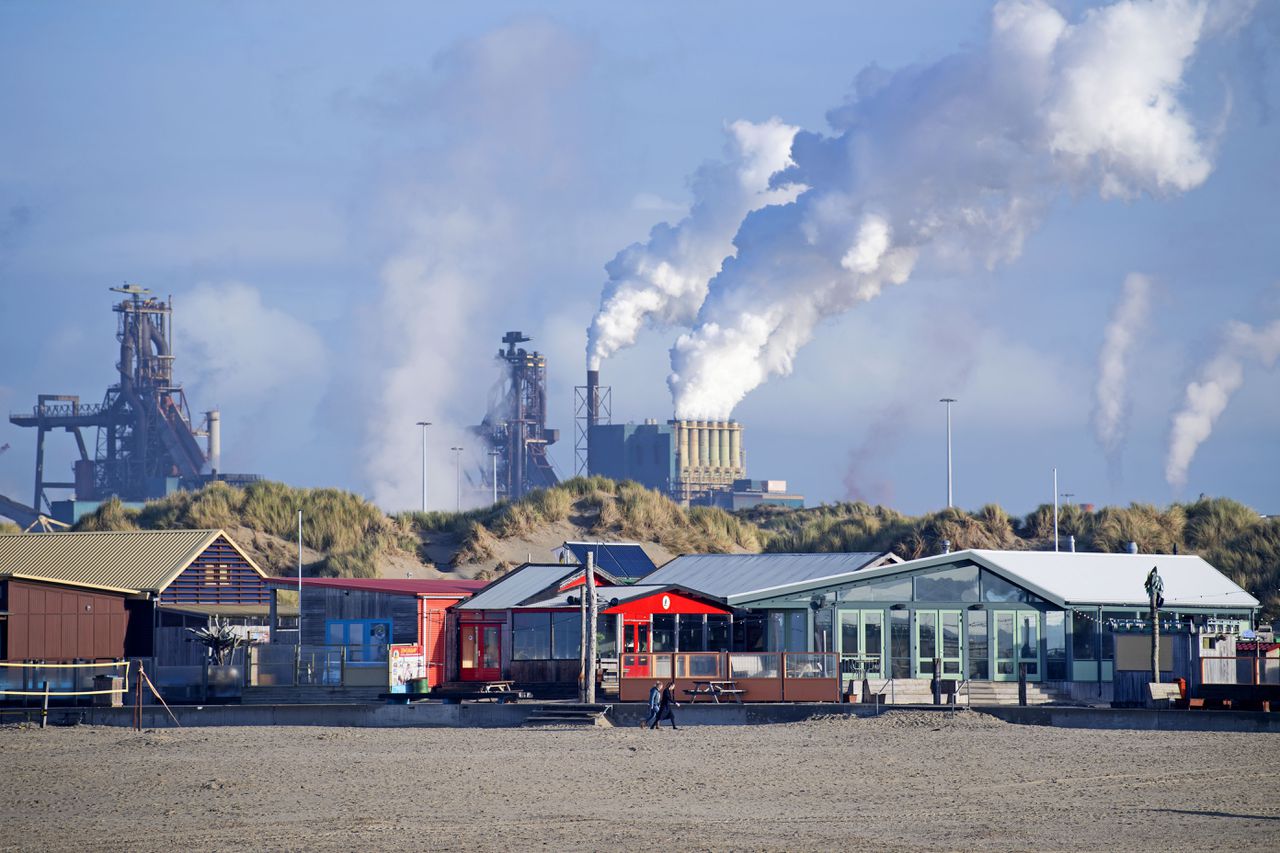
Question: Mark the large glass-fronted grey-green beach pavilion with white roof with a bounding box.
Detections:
[728,551,1258,684]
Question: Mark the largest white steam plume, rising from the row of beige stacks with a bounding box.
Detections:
[668,0,1248,419]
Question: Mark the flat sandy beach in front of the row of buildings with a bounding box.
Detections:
[0,712,1280,850]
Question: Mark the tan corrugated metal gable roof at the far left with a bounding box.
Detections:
[0,530,247,592]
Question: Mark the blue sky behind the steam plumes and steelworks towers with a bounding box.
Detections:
[0,1,1280,512]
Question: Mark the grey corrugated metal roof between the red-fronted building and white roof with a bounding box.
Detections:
[644,551,886,598]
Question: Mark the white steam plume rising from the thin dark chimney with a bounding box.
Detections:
[586,118,803,370]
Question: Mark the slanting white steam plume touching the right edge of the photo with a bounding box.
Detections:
[1165,313,1280,488]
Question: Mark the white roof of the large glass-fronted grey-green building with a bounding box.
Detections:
[859,549,1258,608]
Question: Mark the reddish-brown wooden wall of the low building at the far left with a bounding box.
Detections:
[0,579,129,662]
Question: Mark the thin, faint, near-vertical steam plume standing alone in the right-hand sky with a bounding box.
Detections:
[1093,273,1151,471]
